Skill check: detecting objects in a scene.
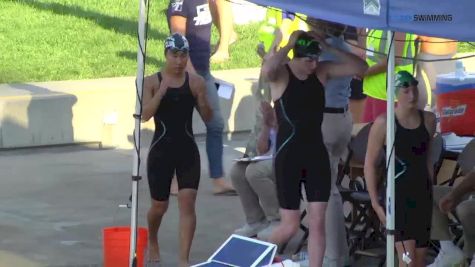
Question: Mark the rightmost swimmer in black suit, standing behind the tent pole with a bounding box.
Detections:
[364,71,436,267]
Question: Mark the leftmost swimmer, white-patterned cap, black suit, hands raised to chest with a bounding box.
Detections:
[142,33,212,266]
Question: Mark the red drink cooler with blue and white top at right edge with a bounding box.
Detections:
[436,72,475,136]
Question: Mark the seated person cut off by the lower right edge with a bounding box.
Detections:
[428,167,475,267]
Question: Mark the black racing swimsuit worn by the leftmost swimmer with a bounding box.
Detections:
[147,72,201,201]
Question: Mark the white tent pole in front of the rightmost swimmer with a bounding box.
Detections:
[386,31,396,267]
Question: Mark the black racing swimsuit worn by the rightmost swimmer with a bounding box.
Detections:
[395,111,432,247]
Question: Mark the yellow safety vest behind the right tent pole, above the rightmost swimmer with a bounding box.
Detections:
[363,30,416,100]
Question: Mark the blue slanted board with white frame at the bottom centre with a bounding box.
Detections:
[192,234,277,267]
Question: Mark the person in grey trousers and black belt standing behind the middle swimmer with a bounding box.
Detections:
[307,18,353,267]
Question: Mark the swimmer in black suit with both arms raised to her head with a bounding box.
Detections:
[262,31,367,266]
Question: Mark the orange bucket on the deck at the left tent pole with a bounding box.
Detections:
[102,226,148,267]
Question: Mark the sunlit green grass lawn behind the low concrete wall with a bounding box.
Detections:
[0,0,259,83]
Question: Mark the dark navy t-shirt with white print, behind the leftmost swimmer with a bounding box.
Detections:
[167,0,212,73]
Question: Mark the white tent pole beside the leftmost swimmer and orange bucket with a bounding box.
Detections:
[129,0,147,267]
